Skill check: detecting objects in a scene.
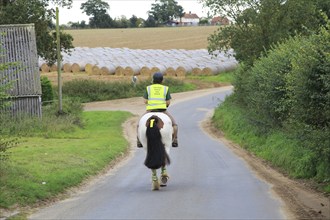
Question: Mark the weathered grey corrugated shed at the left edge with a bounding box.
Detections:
[0,24,42,117]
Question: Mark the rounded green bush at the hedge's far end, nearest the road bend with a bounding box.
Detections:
[235,36,301,129]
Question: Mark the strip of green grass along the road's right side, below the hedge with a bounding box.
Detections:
[212,96,330,193]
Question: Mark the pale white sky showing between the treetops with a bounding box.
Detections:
[53,0,208,24]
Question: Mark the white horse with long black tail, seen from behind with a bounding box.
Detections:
[138,112,173,190]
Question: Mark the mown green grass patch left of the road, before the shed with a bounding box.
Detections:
[0,111,131,208]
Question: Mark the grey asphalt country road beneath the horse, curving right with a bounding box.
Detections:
[30,90,286,219]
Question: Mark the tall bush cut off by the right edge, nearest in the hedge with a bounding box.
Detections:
[286,24,330,128]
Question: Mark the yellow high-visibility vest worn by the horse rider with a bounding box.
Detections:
[147,84,168,110]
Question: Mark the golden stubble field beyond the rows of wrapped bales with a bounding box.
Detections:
[65,26,219,50]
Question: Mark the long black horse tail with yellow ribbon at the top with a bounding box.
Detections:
[144,115,170,169]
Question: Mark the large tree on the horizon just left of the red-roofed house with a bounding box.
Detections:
[148,0,184,25]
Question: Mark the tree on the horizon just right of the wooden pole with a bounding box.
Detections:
[80,0,112,28]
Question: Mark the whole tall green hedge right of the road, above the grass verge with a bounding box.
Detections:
[234,20,330,127]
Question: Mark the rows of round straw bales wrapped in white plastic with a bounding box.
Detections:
[39,47,237,76]
